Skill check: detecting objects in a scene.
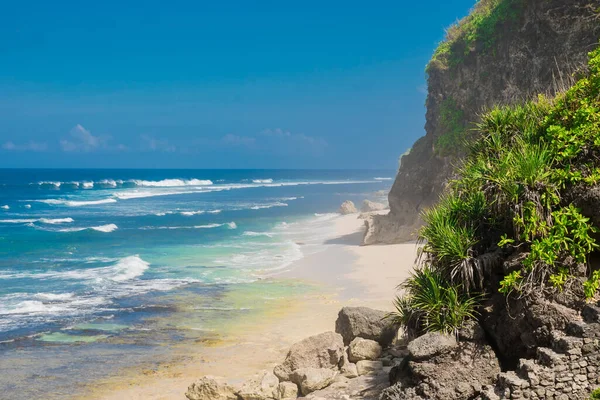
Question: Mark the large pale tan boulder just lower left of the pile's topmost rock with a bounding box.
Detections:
[273,332,344,381]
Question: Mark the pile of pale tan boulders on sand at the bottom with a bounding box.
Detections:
[186,307,404,400]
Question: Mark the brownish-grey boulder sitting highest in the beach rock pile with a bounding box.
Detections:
[335,307,398,347]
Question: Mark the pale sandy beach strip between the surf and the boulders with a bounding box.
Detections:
[77,214,416,400]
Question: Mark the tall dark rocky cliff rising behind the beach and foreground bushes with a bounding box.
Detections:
[364,0,600,244]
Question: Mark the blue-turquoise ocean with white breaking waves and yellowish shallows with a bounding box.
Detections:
[0,169,395,399]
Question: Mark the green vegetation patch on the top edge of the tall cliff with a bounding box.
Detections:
[426,0,523,72]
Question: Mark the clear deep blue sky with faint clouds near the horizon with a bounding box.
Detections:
[0,0,474,169]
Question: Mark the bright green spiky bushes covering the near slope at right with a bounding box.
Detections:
[397,44,600,332]
